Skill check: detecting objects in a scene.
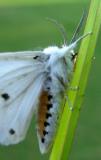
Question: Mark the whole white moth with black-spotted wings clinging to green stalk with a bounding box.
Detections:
[0,15,90,153]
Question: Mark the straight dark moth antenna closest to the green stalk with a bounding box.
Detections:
[70,12,86,44]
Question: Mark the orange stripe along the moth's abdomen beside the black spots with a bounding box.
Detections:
[38,91,48,137]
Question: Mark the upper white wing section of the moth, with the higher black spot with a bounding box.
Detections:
[0,52,44,108]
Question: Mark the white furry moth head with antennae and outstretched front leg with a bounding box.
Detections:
[43,13,91,66]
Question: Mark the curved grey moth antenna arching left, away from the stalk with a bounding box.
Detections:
[46,18,67,45]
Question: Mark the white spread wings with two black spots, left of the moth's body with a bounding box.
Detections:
[0,53,45,145]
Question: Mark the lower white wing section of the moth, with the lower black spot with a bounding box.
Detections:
[0,75,44,145]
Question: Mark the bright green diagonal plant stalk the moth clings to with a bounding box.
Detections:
[50,0,101,160]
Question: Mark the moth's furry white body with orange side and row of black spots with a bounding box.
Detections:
[37,47,74,153]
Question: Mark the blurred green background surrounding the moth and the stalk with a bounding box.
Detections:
[0,0,101,160]
